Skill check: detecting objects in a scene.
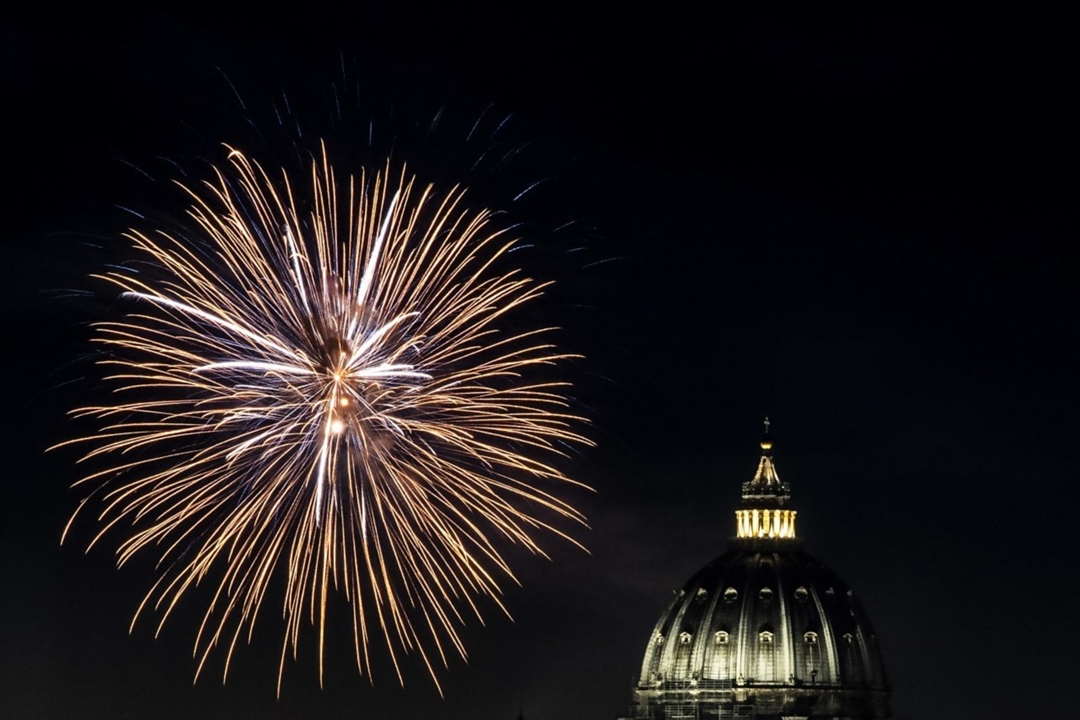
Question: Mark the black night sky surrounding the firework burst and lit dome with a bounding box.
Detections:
[0,5,1080,720]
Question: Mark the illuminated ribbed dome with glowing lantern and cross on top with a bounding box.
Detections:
[631,421,891,720]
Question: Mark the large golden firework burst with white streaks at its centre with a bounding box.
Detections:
[65,148,588,693]
